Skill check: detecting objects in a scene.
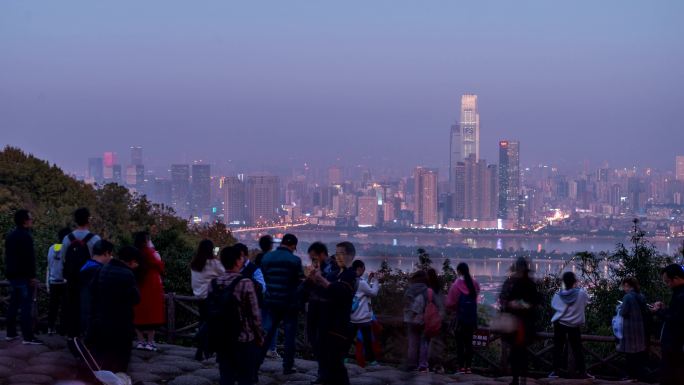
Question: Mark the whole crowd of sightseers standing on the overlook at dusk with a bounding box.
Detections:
[5,208,684,385]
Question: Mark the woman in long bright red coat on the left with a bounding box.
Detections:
[133,231,166,352]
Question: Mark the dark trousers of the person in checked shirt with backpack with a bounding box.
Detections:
[216,342,260,385]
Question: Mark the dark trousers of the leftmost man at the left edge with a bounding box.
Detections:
[7,279,34,340]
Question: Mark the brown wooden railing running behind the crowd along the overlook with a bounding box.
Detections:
[0,281,660,377]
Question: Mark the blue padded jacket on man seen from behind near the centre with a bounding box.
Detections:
[261,246,304,310]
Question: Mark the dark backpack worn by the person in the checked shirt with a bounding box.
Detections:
[203,277,245,353]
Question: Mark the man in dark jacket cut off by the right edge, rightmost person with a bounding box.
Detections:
[654,264,684,385]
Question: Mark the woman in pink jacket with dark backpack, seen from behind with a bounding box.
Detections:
[446,262,480,374]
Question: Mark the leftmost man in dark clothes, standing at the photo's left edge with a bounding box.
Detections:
[5,209,43,345]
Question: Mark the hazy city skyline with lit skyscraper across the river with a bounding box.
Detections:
[79,94,684,236]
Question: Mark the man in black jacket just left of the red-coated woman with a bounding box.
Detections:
[87,246,140,373]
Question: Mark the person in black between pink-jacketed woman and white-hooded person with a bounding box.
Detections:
[499,257,541,385]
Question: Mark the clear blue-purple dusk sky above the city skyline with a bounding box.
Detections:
[0,0,684,177]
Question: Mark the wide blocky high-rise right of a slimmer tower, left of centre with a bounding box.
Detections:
[245,176,280,225]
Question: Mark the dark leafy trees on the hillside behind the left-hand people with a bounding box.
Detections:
[0,147,235,294]
